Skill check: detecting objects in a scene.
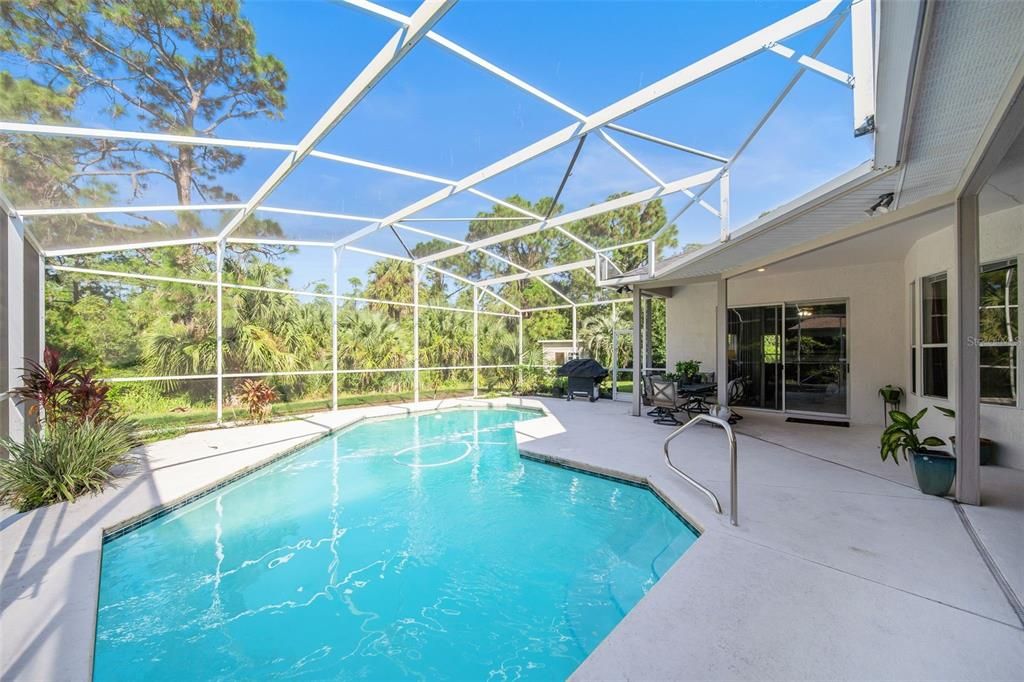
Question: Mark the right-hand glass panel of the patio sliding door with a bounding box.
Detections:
[784,302,849,415]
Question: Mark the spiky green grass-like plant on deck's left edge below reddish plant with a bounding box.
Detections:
[0,419,138,511]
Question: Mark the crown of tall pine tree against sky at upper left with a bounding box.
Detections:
[0,0,287,204]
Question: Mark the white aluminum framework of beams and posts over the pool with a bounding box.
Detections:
[0,0,874,423]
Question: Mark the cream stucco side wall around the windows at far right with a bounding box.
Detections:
[903,201,1024,469]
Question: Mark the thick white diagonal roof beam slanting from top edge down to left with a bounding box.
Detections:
[219,0,456,239]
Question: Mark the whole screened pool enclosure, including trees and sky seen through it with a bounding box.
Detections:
[0,0,874,426]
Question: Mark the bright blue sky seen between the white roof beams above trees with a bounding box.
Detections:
[6,0,870,287]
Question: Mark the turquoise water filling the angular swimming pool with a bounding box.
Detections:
[94,410,695,681]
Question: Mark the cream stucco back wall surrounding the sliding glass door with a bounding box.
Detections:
[666,261,906,424]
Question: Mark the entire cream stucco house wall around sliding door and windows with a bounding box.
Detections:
[666,201,1024,469]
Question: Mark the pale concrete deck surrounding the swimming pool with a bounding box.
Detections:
[0,399,1024,680]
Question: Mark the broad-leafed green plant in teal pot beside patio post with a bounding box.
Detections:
[882,408,956,496]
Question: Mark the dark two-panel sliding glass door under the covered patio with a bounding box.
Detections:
[728,301,849,416]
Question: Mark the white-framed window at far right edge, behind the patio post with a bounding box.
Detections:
[978,258,1020,406]
